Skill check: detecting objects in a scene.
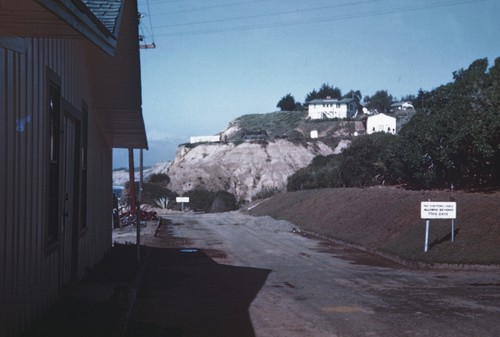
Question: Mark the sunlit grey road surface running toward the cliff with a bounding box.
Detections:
[153,212,500,337]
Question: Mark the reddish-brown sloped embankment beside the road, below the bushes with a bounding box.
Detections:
[249,187,500,265]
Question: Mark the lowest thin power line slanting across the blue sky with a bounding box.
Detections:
[153,0,484,36]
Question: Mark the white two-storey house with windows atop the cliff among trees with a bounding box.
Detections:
[307,97,358,119]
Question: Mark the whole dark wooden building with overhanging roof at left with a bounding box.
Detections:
[0,0,147,337]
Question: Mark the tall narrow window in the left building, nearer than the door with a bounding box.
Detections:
[46,81,61,245]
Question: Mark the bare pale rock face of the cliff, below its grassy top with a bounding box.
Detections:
[164,139,334,200]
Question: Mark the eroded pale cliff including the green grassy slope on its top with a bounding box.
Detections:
[113,112,358,201]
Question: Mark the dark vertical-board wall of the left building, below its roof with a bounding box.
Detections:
[0,37,112,337]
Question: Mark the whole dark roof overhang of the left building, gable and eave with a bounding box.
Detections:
[0,0,148,149]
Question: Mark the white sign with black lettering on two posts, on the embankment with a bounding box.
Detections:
[420,201,457,252]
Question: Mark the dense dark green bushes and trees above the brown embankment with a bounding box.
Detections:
[288,58,500,191]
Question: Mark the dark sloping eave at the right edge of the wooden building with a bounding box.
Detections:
[88,0,148,149]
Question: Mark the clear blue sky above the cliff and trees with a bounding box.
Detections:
[113,0,500,167]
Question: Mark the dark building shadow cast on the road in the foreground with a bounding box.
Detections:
[126,247,270,337]
